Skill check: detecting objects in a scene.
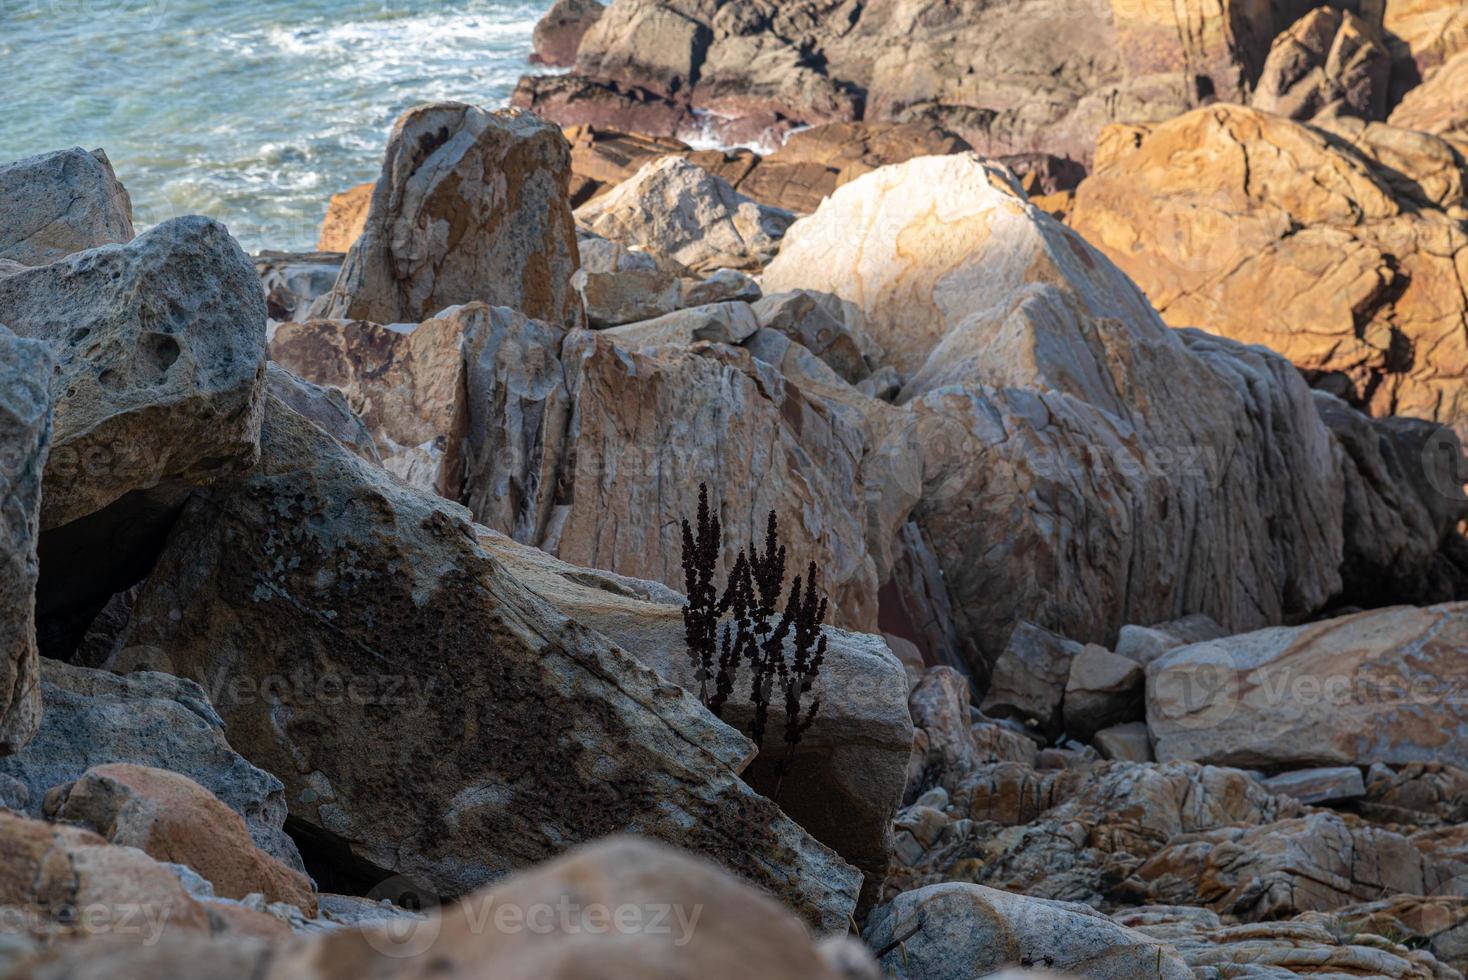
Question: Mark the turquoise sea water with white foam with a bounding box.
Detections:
[0,0,551,251]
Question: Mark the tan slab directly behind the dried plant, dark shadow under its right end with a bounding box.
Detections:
[479,530,913,901]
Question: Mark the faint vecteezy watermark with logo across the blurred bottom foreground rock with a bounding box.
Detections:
[353,877,703,959]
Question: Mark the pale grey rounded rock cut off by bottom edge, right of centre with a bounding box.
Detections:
[863,882,1193,980]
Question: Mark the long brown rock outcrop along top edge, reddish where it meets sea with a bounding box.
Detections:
[515,0,1298,160]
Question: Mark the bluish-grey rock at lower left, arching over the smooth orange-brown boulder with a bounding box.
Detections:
[0,651,302,870]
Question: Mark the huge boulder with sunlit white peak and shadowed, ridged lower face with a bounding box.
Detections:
[763,156,1343,673]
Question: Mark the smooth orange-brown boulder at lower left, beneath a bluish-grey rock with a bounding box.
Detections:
[46,764,316,915]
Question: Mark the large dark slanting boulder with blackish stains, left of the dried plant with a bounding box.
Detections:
[126,402,860,932]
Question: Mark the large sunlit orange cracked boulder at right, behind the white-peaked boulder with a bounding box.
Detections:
[1070,106,1468,431]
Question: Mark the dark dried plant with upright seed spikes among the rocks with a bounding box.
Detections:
[683,484,826,800]
